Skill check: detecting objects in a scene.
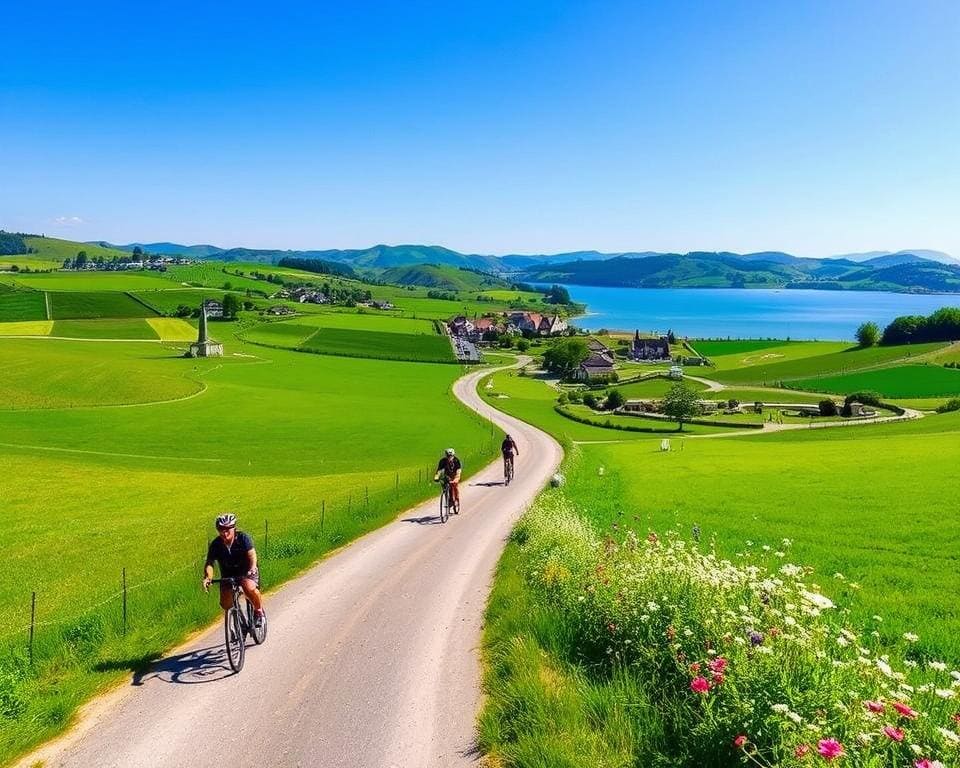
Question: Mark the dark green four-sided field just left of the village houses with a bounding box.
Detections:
[300,328,455,363]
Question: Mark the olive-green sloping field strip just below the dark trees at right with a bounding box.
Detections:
[713,344,944,384]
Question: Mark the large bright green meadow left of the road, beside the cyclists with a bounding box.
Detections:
[0,340,494,762]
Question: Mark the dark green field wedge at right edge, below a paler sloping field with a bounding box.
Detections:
[793,365,960,398]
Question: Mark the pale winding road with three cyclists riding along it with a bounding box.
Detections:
[19,358,562,768]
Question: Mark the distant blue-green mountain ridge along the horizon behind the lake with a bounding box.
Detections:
[86,242,960,292]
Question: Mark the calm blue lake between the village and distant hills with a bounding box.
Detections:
[567,285,960,340]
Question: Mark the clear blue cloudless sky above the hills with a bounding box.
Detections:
[0,0,960,256]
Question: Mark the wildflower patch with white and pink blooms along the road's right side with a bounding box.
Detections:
[481,493,960,768]
